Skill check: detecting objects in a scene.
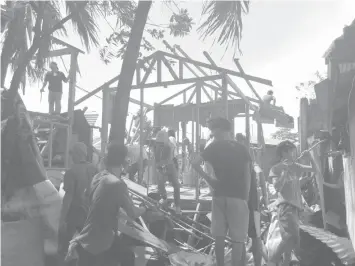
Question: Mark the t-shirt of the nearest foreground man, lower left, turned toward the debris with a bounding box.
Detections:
[76,170,134,255]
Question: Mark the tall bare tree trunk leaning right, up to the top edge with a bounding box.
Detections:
[109,0,152,144]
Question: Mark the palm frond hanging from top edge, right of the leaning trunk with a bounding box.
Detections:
[197,1,249,51]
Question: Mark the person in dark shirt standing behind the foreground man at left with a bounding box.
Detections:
[59,142,97,264]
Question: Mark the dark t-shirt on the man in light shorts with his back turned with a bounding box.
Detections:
[201,140,251,201]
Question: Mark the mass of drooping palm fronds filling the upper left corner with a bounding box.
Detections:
[1,0,133,100]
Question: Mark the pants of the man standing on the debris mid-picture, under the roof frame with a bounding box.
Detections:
[158,164,180,206]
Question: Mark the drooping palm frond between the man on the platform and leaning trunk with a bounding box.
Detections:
[66,1,99,51]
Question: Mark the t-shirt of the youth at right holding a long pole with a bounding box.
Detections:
[269,164,303,209]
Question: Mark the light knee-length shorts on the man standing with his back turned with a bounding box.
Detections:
[211,197,249,243]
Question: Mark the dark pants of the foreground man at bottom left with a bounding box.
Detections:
[77,235,141,266]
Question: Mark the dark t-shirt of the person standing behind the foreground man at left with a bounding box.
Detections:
[63,162,97,227]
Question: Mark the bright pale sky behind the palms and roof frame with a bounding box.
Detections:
[11,0,355,139]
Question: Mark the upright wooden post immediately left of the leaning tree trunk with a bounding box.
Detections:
[100,88,113,156]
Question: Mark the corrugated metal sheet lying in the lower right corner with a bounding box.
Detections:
[300,224,355,265]
